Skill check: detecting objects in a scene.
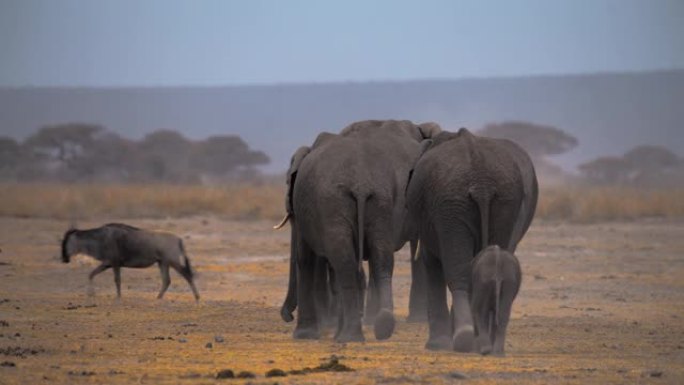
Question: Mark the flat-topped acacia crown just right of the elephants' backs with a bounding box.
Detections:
[479,121,578,158]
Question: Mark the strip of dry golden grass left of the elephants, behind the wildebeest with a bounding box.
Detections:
[0,184,285,219]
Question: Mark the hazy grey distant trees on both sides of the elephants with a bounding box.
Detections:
[0,121,684,186]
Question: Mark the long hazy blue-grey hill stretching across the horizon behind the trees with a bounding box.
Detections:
[0,70,684,172]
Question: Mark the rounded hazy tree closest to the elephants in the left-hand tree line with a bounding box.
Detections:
[190,135,270,176]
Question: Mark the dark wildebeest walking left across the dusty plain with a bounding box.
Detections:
[62,223,199,300]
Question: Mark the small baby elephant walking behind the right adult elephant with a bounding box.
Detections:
[470,246,522,355]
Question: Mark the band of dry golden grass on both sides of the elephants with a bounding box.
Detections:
[0,183,684,222]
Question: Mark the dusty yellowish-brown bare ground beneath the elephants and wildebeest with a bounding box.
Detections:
[0,214,684,384]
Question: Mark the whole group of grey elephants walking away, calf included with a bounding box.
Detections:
[277,120,538,354]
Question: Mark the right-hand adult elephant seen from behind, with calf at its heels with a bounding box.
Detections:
[406,128,538,352]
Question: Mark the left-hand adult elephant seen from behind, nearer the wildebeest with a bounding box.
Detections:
[281,121,439,341]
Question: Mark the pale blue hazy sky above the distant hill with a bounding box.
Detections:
[0,0,684,86]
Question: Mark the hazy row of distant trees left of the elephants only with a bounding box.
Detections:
[0,123,270,183]
